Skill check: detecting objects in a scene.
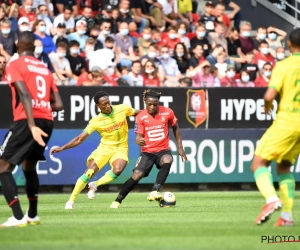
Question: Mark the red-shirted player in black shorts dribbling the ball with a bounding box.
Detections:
[110,89,188,208]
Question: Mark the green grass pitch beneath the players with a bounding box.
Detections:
[0,192,300,250]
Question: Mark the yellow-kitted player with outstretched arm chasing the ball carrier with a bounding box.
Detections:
[50,91,140,209]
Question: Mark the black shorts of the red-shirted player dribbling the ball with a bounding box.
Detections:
[133,150,173,177]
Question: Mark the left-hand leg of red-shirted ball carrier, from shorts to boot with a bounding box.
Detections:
[110,153,156,208]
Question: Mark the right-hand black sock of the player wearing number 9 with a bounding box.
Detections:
[23,170,40,218]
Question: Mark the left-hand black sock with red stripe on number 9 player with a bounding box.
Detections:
[0,172,24,220]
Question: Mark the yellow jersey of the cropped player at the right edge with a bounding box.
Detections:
[268,53,300,131]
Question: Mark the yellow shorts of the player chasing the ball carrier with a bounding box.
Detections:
[86,146,128,170]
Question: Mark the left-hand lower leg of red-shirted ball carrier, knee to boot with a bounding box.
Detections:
[110,169,145,208]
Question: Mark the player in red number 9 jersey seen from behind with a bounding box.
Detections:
[0,31,62,227]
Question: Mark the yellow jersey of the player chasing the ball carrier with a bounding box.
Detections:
[84,104,136,147]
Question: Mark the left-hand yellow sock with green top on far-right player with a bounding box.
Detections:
[254,167,277,200]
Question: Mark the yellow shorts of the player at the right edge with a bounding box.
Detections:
[254,124,300,164]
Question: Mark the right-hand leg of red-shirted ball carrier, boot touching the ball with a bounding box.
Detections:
[147,151,173,201]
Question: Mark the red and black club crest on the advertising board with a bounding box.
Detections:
[186,90,207,128]
